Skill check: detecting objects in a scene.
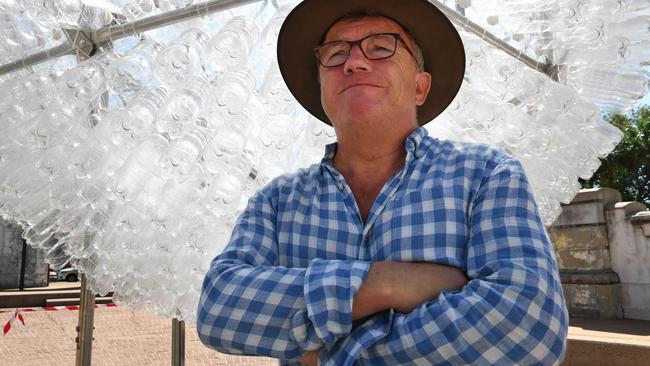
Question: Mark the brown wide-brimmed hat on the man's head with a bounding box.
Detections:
[278,0,465,126]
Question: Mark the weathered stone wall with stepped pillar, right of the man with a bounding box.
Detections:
[548,188,650,320]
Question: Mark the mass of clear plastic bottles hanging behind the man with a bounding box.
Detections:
[0,0,650,320]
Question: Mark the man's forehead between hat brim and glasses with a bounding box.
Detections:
[325,15,406,41]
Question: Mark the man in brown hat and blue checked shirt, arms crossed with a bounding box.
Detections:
[197,0,567,365]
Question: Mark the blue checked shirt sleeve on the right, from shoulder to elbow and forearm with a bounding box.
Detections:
[320,159,568,366]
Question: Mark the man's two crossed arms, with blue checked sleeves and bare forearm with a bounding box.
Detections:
[197,157,567,365]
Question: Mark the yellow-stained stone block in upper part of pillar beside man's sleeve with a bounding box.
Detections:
[547,225,609,250]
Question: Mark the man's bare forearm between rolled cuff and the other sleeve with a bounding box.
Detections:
[352,262,467,320]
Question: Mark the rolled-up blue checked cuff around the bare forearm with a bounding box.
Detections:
[291,258,371,350]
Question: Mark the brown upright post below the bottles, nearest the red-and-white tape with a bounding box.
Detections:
[75,273,95,366]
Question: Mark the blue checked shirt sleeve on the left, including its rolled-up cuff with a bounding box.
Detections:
[196,185,370,359]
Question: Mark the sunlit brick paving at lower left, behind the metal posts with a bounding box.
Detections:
[0,308,277,366]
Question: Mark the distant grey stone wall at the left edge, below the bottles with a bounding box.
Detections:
[0,219,48,289]
